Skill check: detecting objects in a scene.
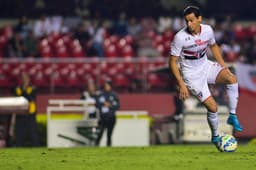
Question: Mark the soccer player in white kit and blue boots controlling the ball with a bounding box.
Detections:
[169,6,243,146]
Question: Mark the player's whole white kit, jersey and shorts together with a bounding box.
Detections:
[170,24,223,102]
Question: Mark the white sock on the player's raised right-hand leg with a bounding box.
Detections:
[227,83,239,114]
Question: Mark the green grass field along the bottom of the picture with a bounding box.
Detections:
[0,145,256,170]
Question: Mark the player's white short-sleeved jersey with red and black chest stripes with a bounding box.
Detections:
[170,24,216,72]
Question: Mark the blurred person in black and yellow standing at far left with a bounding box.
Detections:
[14,73,39,147]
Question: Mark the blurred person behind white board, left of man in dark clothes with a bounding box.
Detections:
[81,80,99,118]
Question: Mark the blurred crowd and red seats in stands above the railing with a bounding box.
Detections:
[0,13,256,63]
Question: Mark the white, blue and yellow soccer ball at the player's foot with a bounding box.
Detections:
[219,135,237,152]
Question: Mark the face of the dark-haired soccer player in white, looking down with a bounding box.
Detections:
[185,13,202,34]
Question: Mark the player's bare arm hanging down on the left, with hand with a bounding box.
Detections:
[169,55,189,100]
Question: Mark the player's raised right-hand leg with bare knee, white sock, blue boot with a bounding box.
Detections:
[216,68,243,131]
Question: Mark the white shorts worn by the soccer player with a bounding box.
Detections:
[182,61,223,102]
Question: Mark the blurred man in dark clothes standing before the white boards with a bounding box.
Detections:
[96,81,120,146]
